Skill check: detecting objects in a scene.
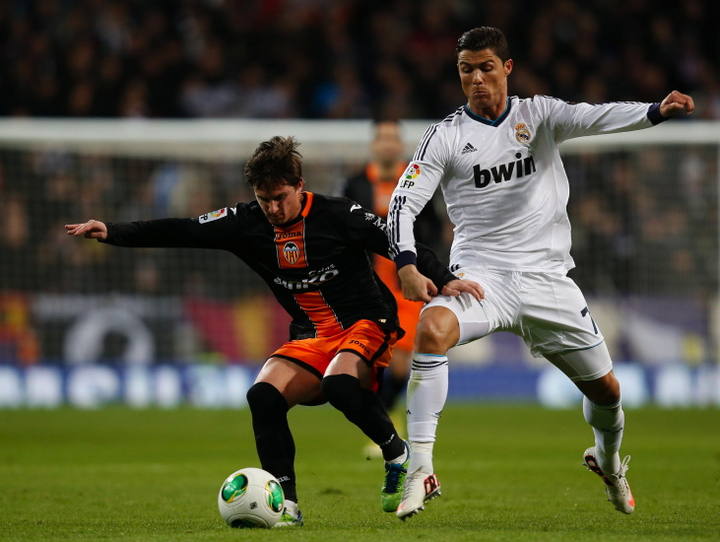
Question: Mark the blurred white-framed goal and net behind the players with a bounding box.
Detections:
[0,119,720,406]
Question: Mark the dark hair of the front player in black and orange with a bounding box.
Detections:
[245,136,302,189]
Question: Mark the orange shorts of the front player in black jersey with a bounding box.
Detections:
[270,320,397,391]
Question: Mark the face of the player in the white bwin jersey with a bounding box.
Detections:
[458,49,513,118]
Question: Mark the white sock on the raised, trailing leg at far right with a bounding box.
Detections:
[583,397,625,474]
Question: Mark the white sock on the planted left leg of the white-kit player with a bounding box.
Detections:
[407,354,448,473]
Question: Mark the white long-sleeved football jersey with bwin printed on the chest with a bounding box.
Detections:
[388,96,662,273]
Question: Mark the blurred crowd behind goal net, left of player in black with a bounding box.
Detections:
[0,150,257,297]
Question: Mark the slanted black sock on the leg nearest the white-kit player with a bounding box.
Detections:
[322,375,405,461]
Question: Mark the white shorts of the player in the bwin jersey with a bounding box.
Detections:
[423,268,612,380]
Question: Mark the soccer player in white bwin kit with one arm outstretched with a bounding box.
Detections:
[388,27,694,519]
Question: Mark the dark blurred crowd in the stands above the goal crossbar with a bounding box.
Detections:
[0,0,720,119]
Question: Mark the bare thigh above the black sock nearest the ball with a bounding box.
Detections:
[255,357,321,407]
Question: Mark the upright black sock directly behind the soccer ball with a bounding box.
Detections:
[247,382,297,502]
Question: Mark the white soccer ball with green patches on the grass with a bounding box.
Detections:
[218,467,285,528]
